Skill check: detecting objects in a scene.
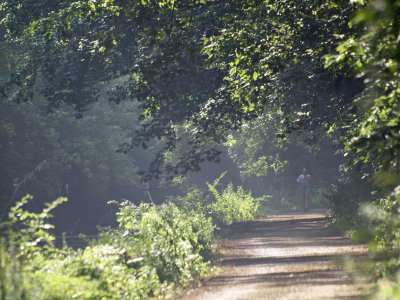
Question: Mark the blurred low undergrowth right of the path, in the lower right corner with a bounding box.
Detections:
[329,178,400,300]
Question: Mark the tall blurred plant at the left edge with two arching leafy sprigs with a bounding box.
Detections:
[0,195,67,299]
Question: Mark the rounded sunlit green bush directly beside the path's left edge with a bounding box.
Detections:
[105,201,214,284]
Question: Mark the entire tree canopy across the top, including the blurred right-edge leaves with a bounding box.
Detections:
[1,0,399,183]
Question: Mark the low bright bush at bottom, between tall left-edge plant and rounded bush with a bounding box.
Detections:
[25,244,160,300]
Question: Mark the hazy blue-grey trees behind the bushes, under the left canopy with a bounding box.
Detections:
[0,95,151,231]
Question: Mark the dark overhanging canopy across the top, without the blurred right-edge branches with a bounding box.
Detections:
[2,0,357,179]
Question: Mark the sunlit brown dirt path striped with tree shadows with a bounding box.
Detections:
[174,210,369,300]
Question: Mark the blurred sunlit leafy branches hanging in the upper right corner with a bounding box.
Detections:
[327,0,400,178]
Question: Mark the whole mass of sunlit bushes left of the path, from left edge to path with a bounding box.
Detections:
[0,197,214,300]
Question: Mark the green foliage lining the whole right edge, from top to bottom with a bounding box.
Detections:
[326,0,400,299]
